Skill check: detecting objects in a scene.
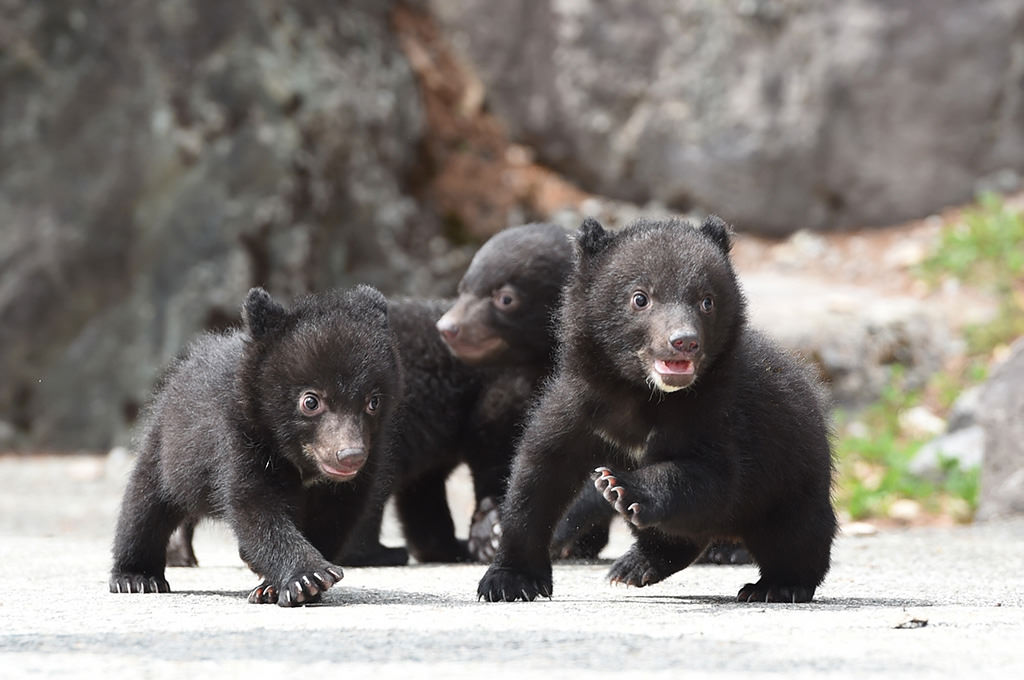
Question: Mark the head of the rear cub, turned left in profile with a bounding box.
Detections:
[437,222,572,365]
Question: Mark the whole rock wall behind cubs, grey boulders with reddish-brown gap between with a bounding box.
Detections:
[0,0,1024,450]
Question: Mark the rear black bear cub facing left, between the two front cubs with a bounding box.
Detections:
[437,222,577,562]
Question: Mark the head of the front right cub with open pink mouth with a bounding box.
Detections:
[562,216,745,392]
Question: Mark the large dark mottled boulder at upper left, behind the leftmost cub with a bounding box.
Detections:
[0,0,452,450]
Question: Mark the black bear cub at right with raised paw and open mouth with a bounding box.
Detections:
[477,217,836,602]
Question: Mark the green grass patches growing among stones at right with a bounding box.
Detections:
[836,194,1024,520]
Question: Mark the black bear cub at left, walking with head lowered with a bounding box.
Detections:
[110,286,401,606]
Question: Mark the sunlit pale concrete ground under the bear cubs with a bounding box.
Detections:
[0,450,1024,679]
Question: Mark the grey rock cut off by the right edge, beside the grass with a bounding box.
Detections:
[978,338,1024,519]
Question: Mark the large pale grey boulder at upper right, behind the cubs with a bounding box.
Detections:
[429,0,1024,235]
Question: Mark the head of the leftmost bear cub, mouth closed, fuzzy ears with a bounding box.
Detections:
[240,286,401,482]
